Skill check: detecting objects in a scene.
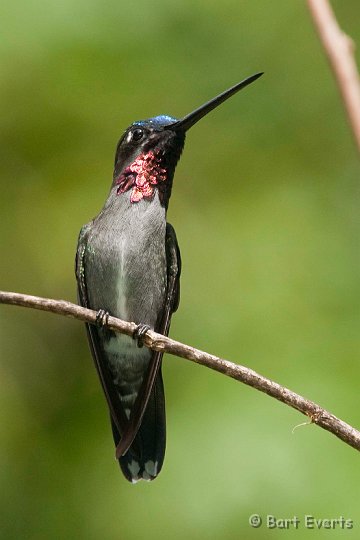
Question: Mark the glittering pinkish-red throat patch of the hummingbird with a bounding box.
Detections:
[116,149,167,203]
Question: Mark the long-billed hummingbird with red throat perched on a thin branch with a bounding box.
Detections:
[75,73,262,483]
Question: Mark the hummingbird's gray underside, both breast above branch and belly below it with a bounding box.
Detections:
[85,191,166,412]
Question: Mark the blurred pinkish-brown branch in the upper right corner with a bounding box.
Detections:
[307,0,360,151]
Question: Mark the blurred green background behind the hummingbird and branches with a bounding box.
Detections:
[0,0,360,540]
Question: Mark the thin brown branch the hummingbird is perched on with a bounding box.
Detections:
[0,291,360,450]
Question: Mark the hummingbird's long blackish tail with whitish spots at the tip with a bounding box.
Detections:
[111,369,166,483]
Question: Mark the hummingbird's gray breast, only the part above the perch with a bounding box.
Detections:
[86,193,166,327]
